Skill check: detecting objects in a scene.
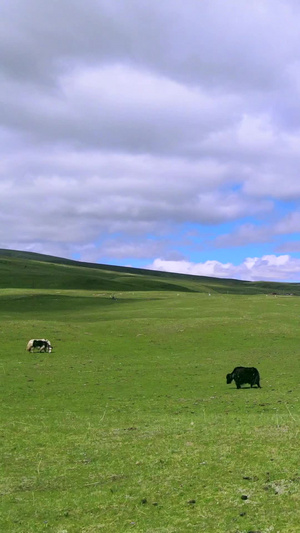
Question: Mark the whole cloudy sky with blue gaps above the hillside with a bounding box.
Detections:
[0,0,300,281]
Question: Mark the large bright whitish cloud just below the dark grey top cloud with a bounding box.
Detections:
[2,66,238,156]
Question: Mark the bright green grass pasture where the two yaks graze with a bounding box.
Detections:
[0,289,300,533]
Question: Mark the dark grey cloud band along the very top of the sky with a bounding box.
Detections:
[2,0,299,89]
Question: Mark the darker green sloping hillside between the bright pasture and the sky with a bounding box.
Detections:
[0,249,300,295]
